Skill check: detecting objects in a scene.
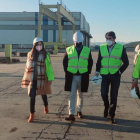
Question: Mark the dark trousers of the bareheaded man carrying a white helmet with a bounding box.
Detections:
[101,74,120,117]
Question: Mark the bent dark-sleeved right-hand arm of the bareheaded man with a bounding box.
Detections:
[119,47,129,74]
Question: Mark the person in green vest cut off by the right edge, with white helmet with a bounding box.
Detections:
[131,45,140,98]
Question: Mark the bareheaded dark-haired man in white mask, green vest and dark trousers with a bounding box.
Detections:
[95,31,129,123]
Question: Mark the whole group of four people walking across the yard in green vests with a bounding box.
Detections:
[21,31,140,123]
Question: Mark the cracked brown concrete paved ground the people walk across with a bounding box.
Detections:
[0,52,140,140]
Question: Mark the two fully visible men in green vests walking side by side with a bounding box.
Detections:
[63,31,129,123]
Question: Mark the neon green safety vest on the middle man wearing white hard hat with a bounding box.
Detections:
[66,45,90,74]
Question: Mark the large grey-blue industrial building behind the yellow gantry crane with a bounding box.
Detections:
[0,11,92,48]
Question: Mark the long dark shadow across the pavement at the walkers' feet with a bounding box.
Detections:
[34,115,140,134]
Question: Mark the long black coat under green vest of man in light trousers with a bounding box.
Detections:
[63,47,93,92]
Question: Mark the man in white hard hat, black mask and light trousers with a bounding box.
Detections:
[63,32,93,121]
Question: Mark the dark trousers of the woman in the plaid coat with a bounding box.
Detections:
[30,80,48,113]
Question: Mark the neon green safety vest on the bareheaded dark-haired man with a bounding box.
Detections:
[100,43,123,75]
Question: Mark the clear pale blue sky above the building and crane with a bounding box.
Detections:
[0,0,140,42]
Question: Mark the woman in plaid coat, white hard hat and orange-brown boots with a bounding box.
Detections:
[21,37,54,122]
